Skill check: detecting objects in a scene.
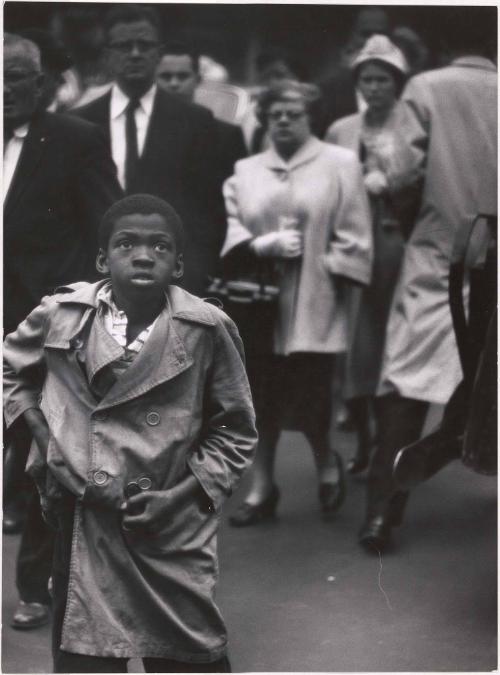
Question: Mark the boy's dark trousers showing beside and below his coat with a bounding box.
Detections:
[52,495,231,673]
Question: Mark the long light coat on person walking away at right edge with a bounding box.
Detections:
[378,56,497,404]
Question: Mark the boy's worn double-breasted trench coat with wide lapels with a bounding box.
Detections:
[4,282,256,663]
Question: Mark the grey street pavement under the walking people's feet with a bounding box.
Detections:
[2,422,498,673]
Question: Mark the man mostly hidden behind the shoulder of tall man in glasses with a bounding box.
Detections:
[156,42,247,182]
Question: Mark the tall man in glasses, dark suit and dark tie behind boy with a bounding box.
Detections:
[75,4,226,294]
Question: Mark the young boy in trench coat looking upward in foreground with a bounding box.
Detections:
[4,195,256,673]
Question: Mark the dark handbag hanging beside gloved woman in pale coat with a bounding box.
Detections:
[207,260,280,356]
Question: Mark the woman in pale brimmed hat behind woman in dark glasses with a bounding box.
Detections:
[326,35,421,480]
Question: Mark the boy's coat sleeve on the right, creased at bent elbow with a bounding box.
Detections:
[188,313,257,511]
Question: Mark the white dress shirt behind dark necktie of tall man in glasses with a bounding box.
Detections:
[109,84,156,188]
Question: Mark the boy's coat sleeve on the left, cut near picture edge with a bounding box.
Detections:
[3,297,53,427]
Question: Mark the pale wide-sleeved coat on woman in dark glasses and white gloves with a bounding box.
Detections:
[222,136,373,355]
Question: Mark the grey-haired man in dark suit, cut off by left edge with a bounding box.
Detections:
[3,35,121,629]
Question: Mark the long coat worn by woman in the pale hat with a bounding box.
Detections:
[326,102,422,399]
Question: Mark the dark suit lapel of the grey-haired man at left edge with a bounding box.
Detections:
[4,117,50,217]
